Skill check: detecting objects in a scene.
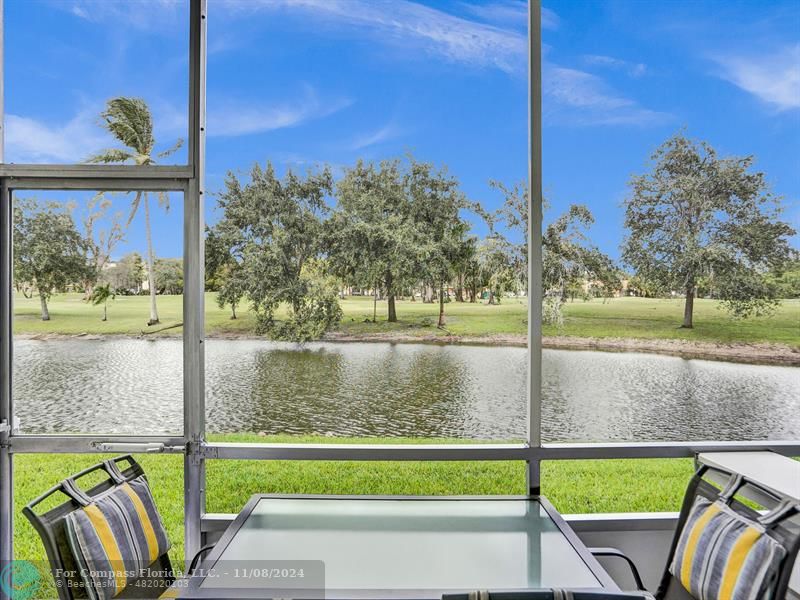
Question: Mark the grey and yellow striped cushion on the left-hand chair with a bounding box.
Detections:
[65,477,170,599]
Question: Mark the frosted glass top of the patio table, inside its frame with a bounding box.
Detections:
[200,498,602,590]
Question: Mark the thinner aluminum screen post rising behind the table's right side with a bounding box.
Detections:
[527,0,542,495]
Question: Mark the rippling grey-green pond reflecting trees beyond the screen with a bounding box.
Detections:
[13,338,800,441]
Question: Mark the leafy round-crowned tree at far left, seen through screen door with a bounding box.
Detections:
[14,200,89,321]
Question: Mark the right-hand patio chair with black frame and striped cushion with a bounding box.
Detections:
[589,465,800,600]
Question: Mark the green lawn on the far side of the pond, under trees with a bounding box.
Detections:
[14,293,800,346]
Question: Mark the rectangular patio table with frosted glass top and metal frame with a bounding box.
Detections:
[171,494,619,599]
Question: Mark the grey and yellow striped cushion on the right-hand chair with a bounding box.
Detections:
[669,498,787,600]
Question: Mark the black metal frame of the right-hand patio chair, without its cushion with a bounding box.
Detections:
[589,465,800,600]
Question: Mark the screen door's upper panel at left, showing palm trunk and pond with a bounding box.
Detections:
[12,190,183,436]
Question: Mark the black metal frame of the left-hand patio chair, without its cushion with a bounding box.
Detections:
[22,454,174,600]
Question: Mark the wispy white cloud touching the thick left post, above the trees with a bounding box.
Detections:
[208,88,352,137]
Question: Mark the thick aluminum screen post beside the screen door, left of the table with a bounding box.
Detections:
[183,0,207,568]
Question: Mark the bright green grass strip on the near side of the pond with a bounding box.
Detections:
[14,435,692,597]
